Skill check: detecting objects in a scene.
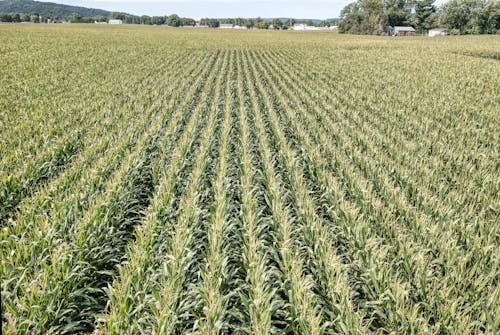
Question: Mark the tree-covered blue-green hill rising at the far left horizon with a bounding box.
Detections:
[0,0,110,19]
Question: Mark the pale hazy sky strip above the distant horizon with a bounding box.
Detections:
[48,0,364,19]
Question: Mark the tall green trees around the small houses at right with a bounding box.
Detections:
[339,0,500,35]
